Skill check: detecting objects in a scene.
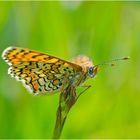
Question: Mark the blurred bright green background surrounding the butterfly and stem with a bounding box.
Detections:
[0,1,140,138]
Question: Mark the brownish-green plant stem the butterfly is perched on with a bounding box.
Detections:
[53,86,77,139]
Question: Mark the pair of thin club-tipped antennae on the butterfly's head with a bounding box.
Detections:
[95,56,130,66]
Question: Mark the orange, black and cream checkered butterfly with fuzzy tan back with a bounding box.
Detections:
[2,47,98,95]
